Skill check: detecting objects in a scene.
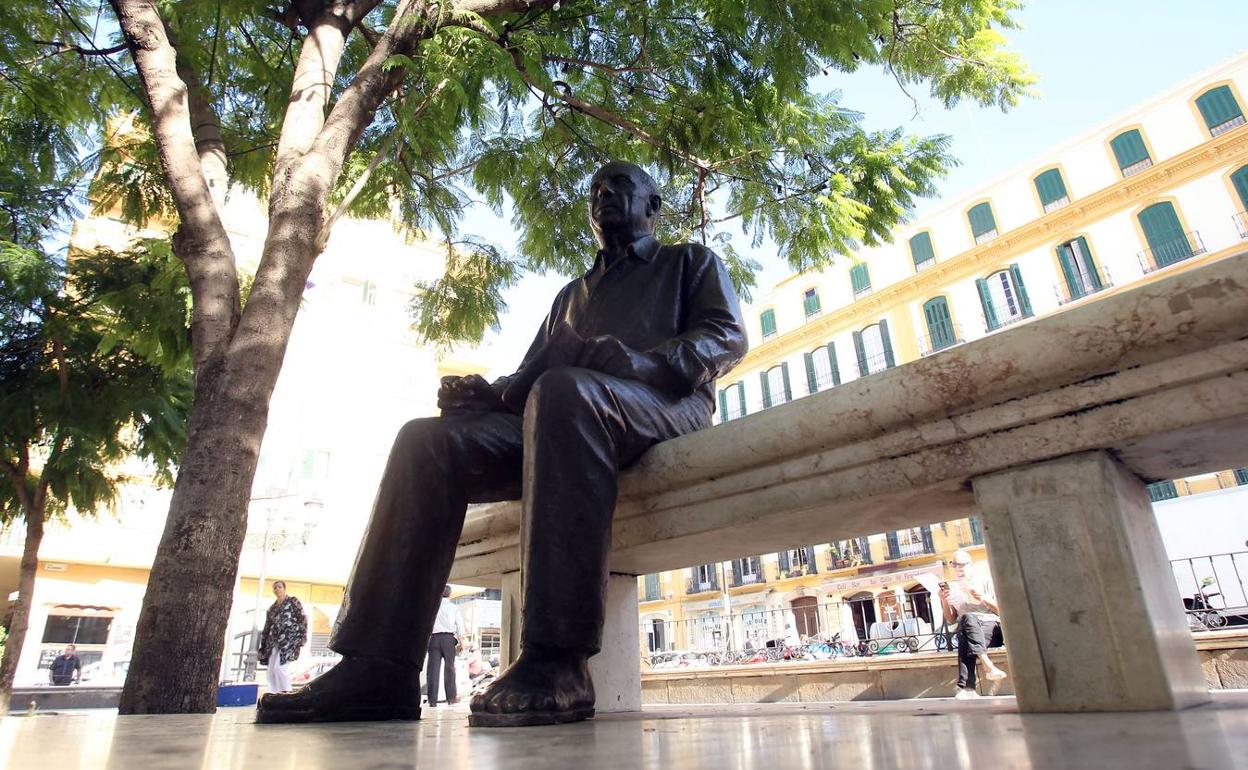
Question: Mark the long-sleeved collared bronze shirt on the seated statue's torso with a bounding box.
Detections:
[511,236,746,403]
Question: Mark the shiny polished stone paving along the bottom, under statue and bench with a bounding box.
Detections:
[0,690,1248,770]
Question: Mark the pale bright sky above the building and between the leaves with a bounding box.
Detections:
[464,0,1248,374]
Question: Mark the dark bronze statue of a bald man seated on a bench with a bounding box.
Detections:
[248,162,746,726]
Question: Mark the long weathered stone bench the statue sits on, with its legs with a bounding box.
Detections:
[451,255,1248,711]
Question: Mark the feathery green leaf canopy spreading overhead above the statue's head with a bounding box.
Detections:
[0,0,1033,343]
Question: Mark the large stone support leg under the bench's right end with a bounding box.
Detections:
[973,452,1209,711]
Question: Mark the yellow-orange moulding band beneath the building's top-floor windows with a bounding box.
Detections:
[723,126,1248,371]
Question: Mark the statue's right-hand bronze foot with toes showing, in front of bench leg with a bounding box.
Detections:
[468,645,594,728]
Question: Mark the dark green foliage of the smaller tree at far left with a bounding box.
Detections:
[0,242,192,520]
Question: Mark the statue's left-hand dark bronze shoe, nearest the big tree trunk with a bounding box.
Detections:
[256,658,421,724]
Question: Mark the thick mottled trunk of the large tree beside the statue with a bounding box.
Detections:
[119,223,321,714]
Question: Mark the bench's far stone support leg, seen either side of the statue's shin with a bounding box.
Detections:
[500,572,641,714]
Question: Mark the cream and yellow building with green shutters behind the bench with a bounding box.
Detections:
[638,55,1248,650]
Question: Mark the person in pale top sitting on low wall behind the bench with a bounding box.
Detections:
[940,550,1006,700]
